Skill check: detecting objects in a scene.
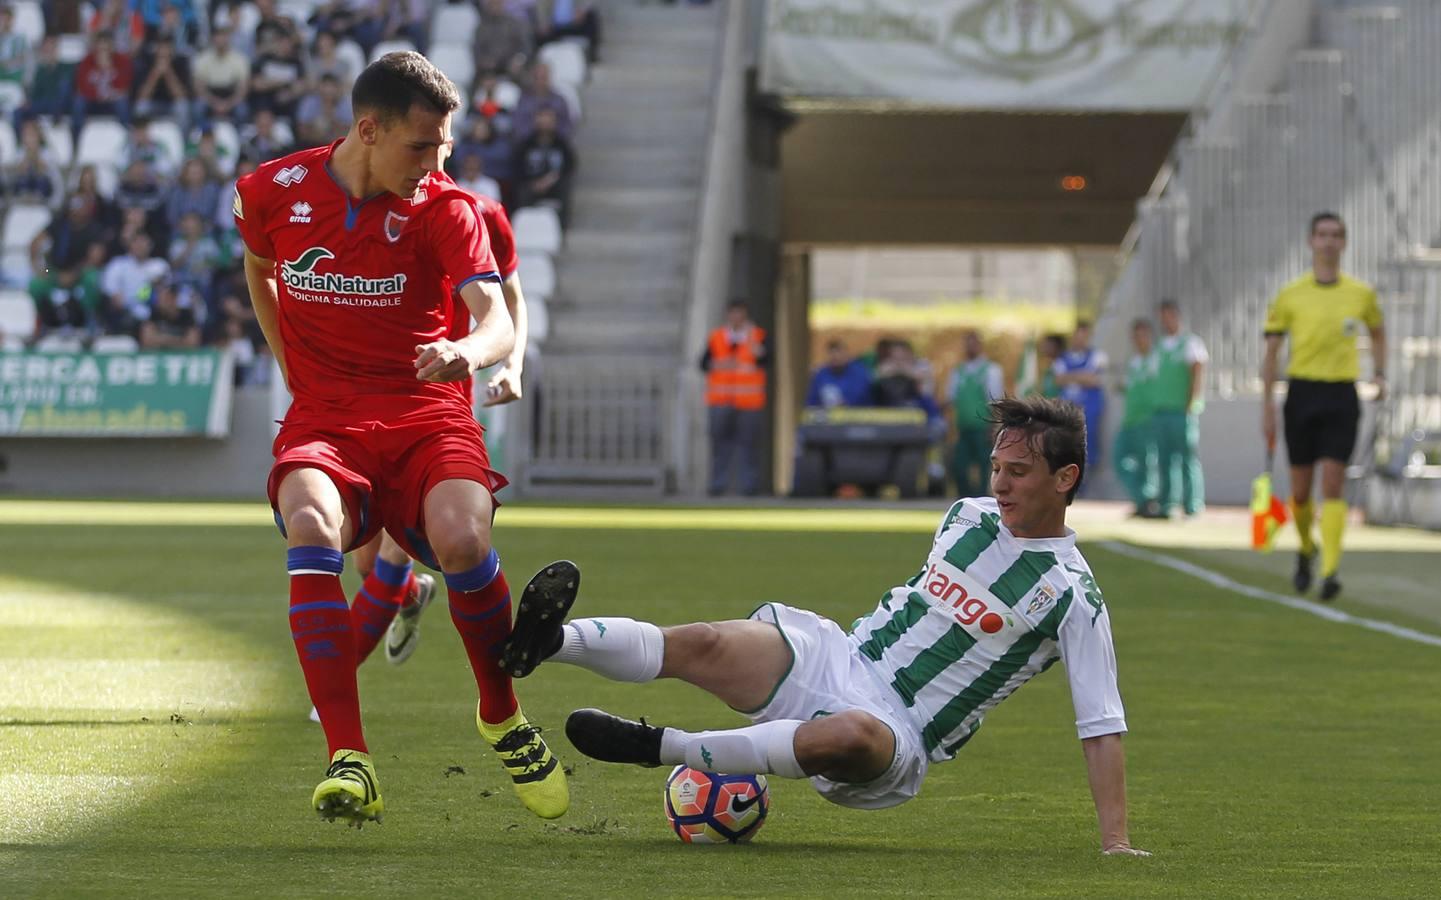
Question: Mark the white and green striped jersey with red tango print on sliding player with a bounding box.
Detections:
[850,498,1125,760]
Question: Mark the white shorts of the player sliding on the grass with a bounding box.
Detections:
[746,603,931,809]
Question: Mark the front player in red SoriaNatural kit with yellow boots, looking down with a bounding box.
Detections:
[235,52,569,825]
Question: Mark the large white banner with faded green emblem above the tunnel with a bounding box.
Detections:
[761,0,1255,111]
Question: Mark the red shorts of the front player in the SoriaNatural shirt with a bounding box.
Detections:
[267,405,509,569]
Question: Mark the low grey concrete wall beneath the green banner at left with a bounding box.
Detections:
[0,387,274,501]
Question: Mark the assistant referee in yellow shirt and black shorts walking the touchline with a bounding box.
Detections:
[1261,212,1386,600]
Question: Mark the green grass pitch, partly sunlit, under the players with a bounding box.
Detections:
[0,501,1441,899]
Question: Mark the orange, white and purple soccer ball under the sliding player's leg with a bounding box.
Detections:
[666,766,771,844]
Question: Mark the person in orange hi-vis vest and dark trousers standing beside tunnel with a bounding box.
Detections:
[700,301,771,497]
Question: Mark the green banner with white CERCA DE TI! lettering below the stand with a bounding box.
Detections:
[0,350,233,438]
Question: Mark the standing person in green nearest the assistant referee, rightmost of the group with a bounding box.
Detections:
[1153,300,1210,516]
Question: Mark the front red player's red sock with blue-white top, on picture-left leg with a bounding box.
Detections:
[290,547,366,756]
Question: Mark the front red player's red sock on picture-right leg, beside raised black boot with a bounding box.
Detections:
[445,550,519,724]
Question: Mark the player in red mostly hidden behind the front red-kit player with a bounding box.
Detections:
[350,196,529,665]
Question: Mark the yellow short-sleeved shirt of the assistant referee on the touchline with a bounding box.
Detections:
[1265,272,1380,382]
